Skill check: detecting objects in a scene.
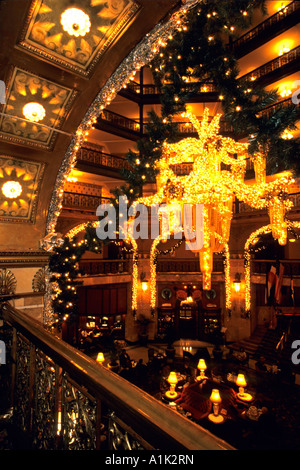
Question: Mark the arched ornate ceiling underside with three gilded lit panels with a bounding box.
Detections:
[0,0,176,244]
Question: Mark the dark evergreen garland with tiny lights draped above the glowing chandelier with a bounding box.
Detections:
[114,0,300,196]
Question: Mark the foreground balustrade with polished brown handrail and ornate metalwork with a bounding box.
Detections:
[0,304,232,451]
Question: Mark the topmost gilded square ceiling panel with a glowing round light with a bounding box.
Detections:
[19,0,140,75]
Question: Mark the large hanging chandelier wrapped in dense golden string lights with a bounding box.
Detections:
[127,108,293,308]
